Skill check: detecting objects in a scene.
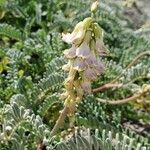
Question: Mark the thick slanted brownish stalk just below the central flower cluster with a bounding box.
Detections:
[50,106,69,136]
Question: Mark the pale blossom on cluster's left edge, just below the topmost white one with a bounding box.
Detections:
[64,45,76,58]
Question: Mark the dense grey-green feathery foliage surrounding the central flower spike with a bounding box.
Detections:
[0,0,150,150]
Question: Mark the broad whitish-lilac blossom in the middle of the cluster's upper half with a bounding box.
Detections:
[76,42,90,58]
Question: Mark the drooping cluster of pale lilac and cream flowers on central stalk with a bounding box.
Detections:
[62,17,107,109]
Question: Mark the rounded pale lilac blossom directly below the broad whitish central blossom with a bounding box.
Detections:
[73,58,86,71]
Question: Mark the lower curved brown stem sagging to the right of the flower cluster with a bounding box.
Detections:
[96,94,142,105]
